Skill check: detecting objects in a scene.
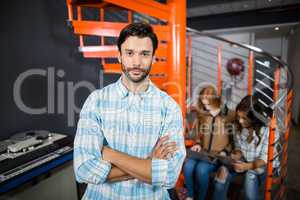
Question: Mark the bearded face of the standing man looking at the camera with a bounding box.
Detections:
[118,36,154,83]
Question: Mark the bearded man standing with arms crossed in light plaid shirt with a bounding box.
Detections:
[74,23,186,200]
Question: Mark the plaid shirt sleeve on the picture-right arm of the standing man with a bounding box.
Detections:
[152,103,186,188]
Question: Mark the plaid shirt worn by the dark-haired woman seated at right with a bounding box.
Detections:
[233,127,279,167]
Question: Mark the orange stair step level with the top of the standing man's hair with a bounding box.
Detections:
[72,20,169,41]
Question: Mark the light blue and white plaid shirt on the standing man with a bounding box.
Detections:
[74,78,186,200]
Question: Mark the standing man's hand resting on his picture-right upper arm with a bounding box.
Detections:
[150,135,178,160]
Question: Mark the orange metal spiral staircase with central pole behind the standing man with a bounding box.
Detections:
[67,0,186,116]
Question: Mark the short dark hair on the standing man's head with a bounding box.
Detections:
[118,22,158,54]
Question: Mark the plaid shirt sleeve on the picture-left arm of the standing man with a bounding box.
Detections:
[74,92,111,184]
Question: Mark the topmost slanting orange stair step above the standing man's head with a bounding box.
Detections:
[105,0,170,21]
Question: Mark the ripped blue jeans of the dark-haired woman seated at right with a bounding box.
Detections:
[213,170,266,200]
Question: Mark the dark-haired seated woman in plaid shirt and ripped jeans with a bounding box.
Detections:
[214,95,279,200]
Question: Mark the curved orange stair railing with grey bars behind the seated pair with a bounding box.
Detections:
[187,28,292,200]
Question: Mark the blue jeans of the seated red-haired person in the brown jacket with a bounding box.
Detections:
[183,158,219,200]
